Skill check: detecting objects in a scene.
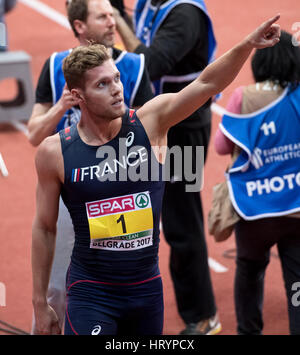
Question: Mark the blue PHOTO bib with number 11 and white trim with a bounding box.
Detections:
[220,86,300,220]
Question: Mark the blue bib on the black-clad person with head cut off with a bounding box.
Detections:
[134,0,216,95]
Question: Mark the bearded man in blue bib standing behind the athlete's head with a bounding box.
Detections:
[28,0,153,332]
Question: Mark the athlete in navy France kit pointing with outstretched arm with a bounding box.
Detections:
[32,16,280,335]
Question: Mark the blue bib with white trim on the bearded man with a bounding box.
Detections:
[50,49,145,132]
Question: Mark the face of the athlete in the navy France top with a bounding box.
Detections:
[82,59,125,120]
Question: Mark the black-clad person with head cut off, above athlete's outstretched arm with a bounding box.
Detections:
[115,0,221,335]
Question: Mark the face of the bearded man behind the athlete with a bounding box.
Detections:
[82,0,116,47]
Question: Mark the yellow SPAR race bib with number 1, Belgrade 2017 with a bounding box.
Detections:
[86,191,153,251]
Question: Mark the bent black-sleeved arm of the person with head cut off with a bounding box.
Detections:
[115,4,206,80]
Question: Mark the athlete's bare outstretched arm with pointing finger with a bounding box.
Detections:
[138,15,280,140]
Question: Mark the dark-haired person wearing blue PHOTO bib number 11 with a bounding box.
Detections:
[214,31,300,335]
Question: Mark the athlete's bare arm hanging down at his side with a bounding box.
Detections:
[31,135,63,334]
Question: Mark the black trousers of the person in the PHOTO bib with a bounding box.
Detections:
[234,217,300,335]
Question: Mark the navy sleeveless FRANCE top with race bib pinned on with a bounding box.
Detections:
[59,110,164,282]
